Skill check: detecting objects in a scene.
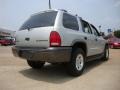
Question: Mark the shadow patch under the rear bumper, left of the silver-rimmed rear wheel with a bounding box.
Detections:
[19,64,74,84]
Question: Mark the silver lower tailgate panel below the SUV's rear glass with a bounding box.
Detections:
[16,27,53,47]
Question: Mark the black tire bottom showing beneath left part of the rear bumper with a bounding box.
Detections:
[27,60,45,69]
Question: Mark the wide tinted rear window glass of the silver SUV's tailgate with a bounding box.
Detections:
[20,11,57,30]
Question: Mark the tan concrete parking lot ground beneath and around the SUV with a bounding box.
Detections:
[0,46,120,90]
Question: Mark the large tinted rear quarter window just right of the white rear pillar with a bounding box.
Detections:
[63,13,79,30]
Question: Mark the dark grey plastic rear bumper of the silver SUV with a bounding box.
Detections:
[12,46,72,62]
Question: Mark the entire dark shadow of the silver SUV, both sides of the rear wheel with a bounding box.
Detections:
[19,60,103,84]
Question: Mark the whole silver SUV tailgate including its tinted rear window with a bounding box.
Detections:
[16,11,57,47]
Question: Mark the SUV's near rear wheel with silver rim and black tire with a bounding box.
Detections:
[67,48,86,76]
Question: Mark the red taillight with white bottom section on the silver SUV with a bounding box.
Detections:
[50,31,61,46]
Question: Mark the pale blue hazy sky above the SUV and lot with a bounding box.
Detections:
[0,0,120,32]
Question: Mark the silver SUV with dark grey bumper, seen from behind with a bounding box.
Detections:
[12,10,109,76]
